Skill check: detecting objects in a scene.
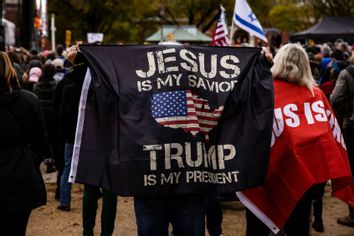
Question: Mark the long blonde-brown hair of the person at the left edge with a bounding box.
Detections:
[0,51,20,93]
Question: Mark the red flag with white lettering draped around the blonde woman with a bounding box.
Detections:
[238,80,354,233]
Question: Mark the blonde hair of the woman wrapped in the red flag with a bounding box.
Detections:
[270,43,316,94]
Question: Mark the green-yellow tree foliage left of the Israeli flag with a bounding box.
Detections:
[48,0,245,44]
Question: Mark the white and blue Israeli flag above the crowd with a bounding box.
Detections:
[233,0,268,42]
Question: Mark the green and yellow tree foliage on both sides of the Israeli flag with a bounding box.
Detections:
[48,0,354,43]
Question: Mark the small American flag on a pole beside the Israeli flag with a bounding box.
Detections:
[212,5,230,46]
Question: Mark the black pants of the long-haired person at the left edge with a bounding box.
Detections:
[0,209,32,236]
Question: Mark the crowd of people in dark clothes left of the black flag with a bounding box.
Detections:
[0,45,117,235]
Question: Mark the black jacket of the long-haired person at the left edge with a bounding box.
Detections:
[0,89,51,214]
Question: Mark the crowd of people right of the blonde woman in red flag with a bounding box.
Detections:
[306,39,354,232]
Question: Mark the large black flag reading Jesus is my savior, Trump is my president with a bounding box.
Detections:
[70,45,273,196]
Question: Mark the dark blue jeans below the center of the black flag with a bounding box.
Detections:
[134,195,206,236]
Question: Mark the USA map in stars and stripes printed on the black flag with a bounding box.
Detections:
[151,90,224,141]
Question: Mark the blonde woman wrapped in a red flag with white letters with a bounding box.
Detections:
[237,44,354,236]
